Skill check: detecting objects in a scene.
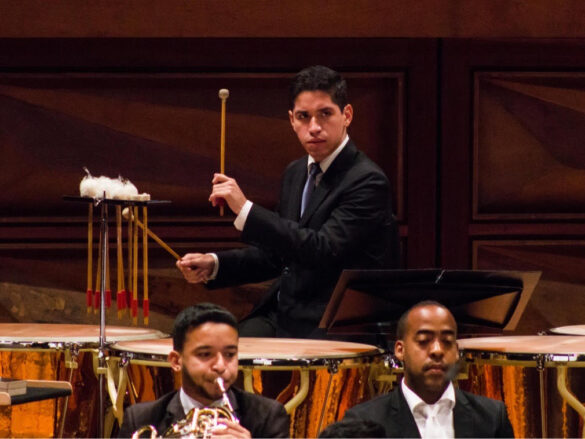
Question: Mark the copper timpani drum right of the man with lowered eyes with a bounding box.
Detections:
[458,335,585,437]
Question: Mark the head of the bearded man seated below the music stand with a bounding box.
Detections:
[394,305,459,404]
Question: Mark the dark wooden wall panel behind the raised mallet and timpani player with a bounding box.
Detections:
[0,73,404,217]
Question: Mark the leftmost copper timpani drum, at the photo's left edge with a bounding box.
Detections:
[0,323,165,437]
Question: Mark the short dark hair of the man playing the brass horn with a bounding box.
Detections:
[173,303,238,352]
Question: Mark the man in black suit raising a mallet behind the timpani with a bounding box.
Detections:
[177,66,398,337]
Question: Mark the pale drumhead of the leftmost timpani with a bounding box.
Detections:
[0,323,166,348]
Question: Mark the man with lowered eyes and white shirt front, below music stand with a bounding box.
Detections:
[342,301,514,438]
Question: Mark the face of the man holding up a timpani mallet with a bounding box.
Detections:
[288,90,353,162]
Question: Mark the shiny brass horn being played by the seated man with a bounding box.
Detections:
[132,378,240,439]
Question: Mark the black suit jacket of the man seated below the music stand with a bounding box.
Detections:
[343,387,514,438]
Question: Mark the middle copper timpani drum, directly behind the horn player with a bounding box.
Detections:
[111,337,384,437]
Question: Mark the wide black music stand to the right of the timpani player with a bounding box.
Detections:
[319,269,541,337]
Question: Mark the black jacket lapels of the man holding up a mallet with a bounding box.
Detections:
[298,139,357,226]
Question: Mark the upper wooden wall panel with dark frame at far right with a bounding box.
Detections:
[439,39,585,268]
